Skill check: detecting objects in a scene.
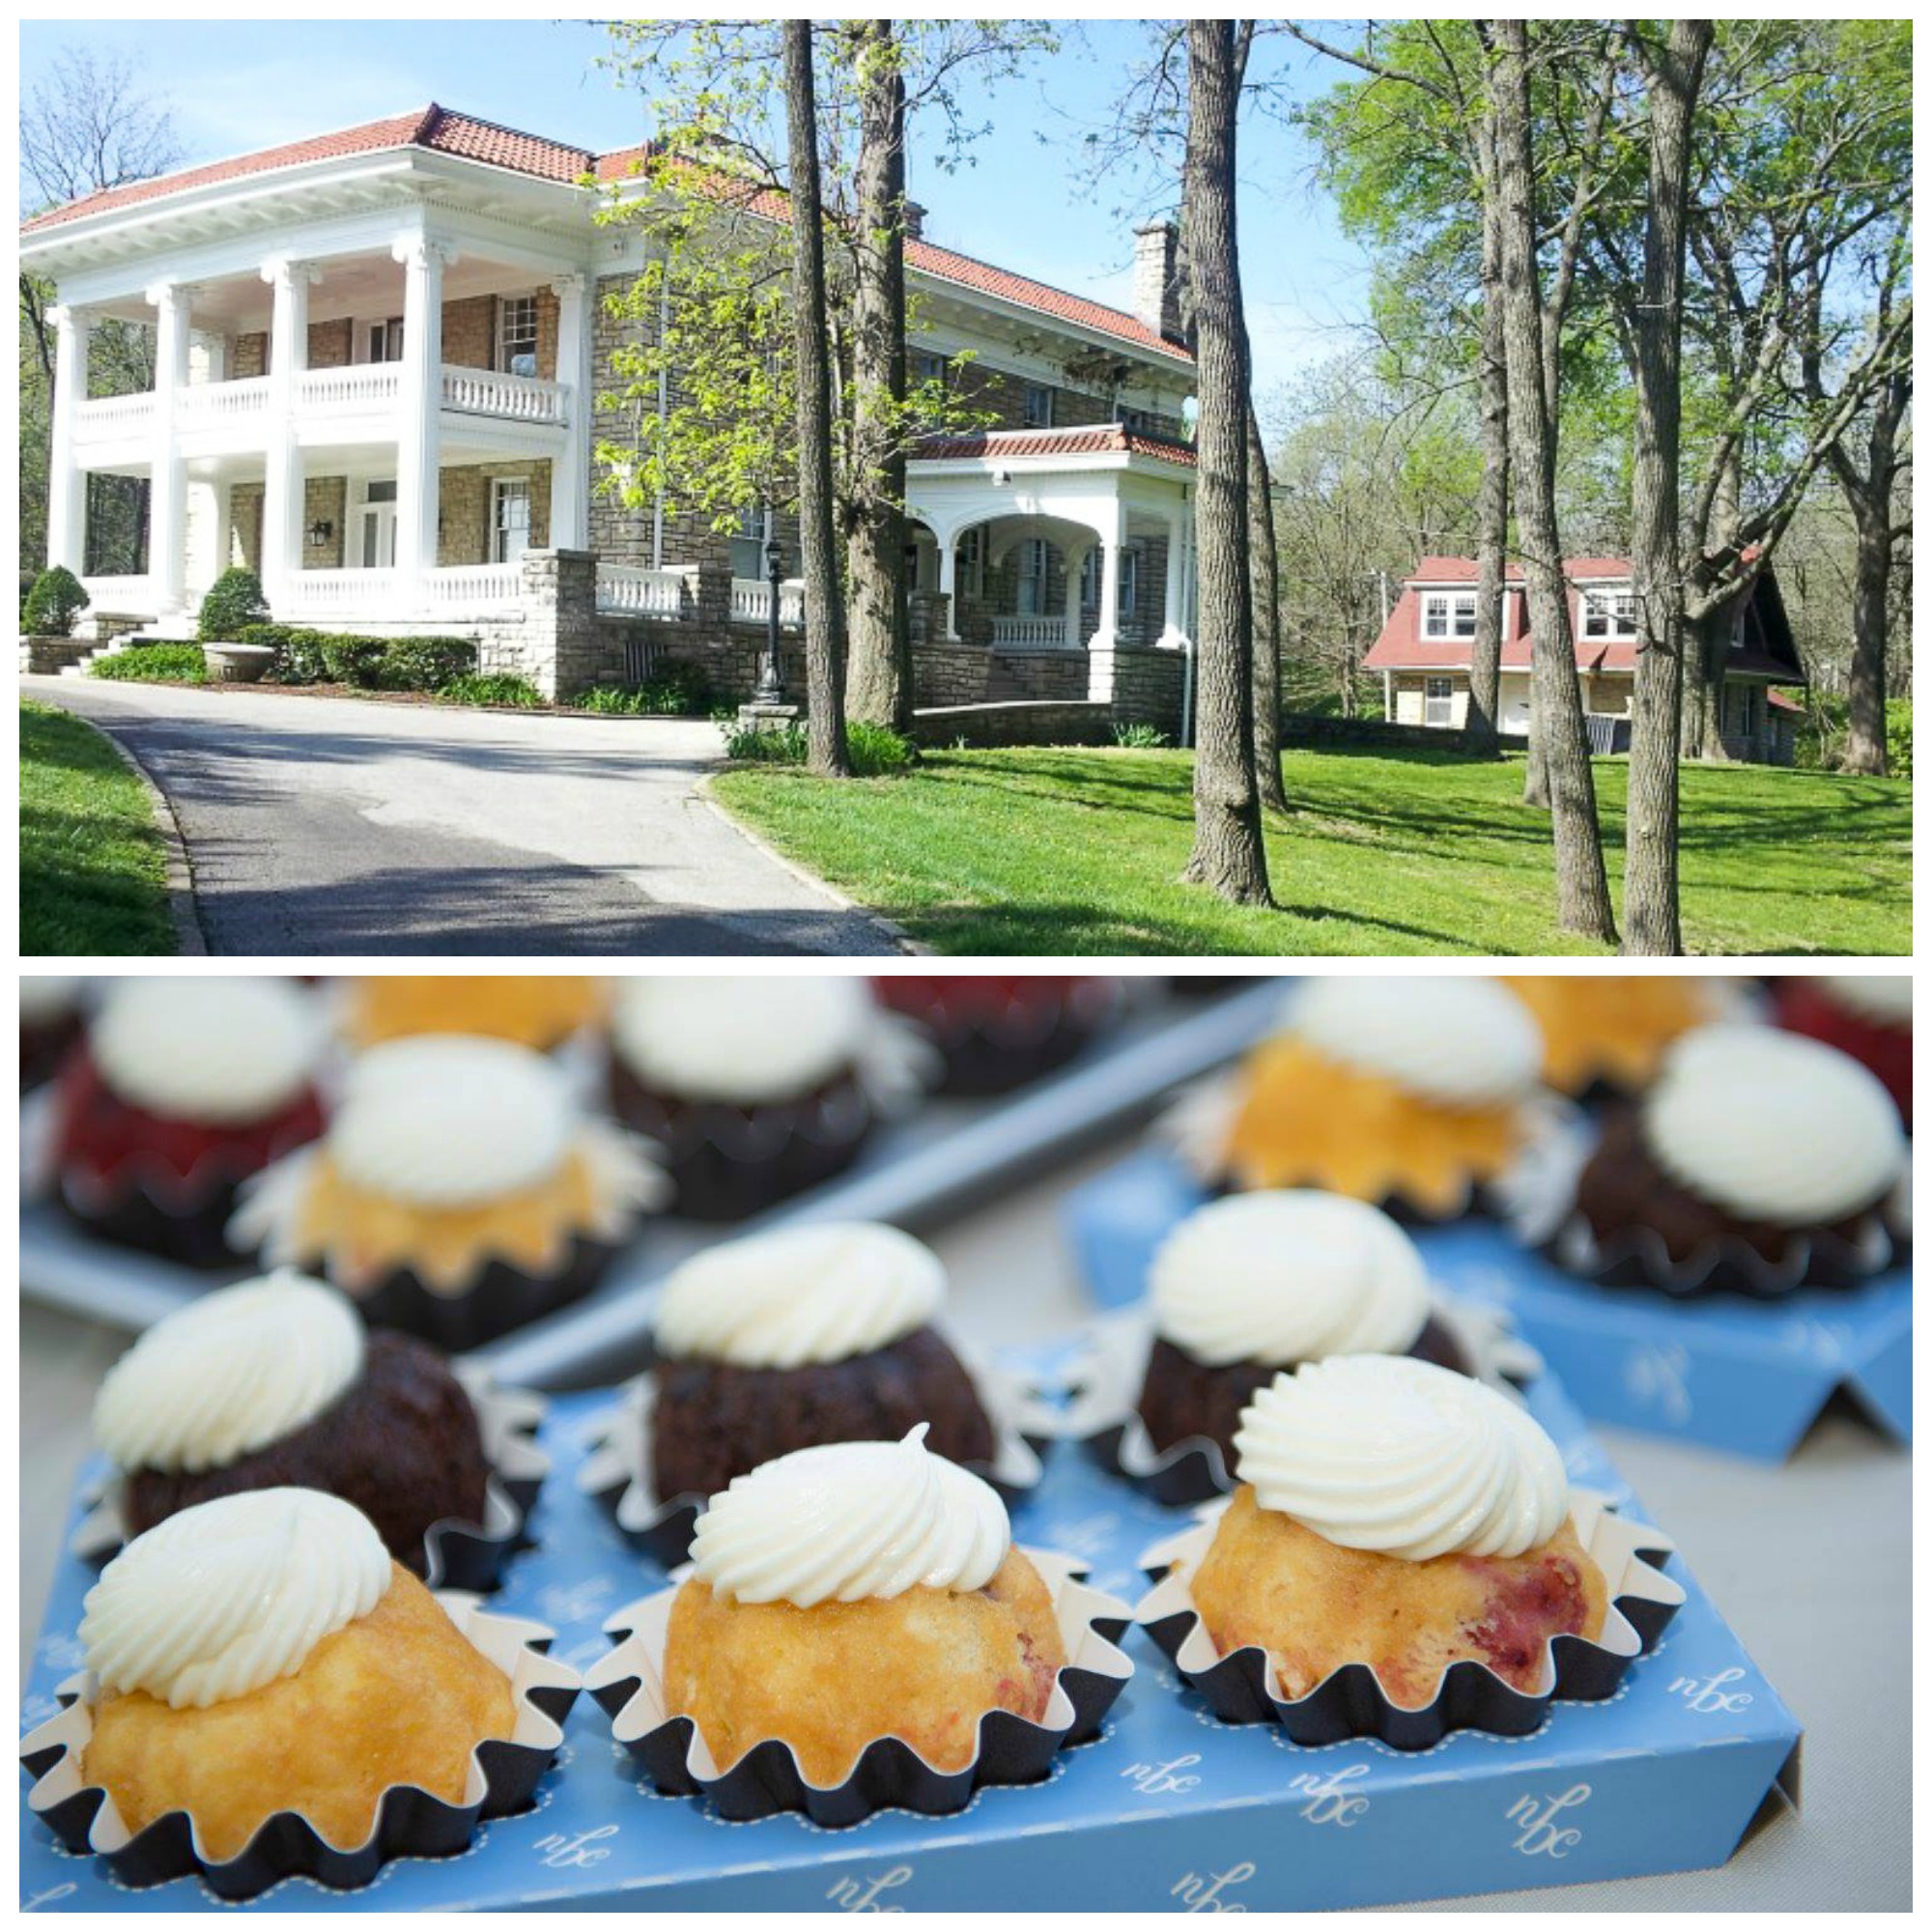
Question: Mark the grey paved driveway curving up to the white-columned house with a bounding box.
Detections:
[19,678,893,954]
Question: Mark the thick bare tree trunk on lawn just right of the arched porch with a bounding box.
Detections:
[1180,19,1271,906]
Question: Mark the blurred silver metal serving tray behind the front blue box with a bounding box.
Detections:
[19,978,1281,1389]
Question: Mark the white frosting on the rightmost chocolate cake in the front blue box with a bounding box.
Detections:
[1148,1188,1430,1368]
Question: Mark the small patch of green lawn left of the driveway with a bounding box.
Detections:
[19,699,174,956]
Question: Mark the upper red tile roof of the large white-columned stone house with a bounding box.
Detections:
[21,102,1192,363]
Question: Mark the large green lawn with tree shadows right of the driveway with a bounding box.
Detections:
[717,750,1911,954]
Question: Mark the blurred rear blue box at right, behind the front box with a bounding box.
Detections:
[1065,1148,1913,1463]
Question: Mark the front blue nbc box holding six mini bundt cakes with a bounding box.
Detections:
[21,1378,1799,1913]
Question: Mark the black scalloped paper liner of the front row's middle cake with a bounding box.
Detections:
[591,1662,1130,1830]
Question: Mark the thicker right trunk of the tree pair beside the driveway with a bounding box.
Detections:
[846,19,912,730]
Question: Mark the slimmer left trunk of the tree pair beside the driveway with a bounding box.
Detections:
[784,19,852,779]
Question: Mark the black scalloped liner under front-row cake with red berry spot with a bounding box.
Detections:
[1142,1548,1679,1750]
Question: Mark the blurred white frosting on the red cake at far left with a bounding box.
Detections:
[87,978,323,1126]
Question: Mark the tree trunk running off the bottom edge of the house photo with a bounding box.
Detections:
[1623,19,1712,956]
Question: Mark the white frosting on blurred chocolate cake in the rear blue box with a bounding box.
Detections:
[1642,1024,1905,1227]
